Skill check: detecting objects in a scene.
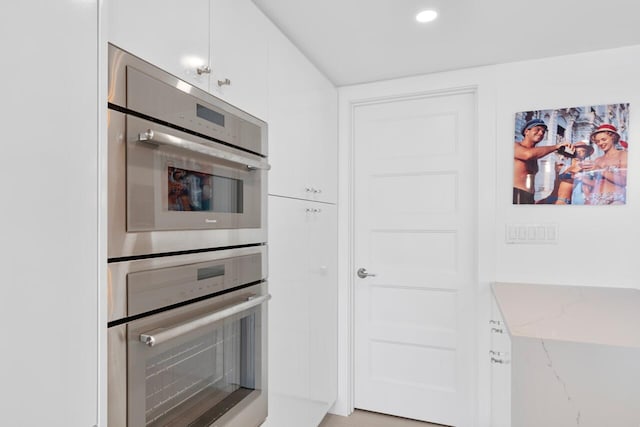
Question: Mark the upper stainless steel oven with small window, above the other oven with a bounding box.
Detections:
[108,45,269,259]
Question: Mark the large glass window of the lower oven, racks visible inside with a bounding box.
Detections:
[145,311,258,427]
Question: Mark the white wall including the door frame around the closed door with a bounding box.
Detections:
[333,46,640,426]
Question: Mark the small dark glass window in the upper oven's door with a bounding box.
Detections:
[167,166,243,213]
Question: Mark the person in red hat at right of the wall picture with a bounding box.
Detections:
[586,123,627,205]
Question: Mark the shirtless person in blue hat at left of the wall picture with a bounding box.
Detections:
[513,119,573,205]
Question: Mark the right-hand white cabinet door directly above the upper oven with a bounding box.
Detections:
[210,0,270,121]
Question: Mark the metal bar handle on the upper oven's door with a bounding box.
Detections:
[137,129,271,170]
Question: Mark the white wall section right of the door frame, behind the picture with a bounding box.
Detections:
[495,46,640,287]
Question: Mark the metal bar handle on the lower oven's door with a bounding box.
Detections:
[140,294,271,347]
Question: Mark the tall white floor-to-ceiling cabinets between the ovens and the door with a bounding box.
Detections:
[258,11,338,427]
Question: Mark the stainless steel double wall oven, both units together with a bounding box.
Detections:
[107,45,269,427]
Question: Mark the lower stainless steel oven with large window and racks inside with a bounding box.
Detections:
[108,246,269,427]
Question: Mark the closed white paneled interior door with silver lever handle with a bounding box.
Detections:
[353,92,477,426]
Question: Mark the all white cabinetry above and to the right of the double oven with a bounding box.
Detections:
[107,5,338,427]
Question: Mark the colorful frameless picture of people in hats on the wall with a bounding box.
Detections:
[513,104,629,205]
